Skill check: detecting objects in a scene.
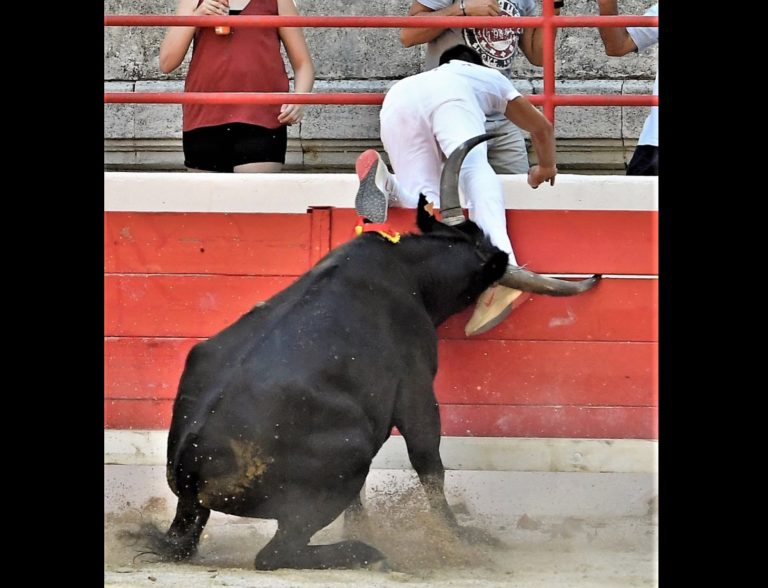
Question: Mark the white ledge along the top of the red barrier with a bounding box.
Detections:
[104,172,659,213]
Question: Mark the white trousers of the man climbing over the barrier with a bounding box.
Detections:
[380,101,517,265]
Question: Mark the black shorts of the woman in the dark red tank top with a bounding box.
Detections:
[183,123,288,172]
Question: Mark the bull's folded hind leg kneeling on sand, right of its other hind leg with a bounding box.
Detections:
[255,500,387,570]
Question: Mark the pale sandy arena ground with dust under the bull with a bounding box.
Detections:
[104,492,658,588]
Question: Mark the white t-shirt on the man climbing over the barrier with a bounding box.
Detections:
[382,59,520,118]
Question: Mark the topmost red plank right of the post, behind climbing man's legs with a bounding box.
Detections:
[331,208,658,275]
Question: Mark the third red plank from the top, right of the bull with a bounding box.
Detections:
[435,340,658,406]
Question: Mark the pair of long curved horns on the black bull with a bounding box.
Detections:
[436,133,600,296]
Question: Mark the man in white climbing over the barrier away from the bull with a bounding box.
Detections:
[356,45,557,335]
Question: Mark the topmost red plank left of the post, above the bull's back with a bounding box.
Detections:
[104,212,310,276]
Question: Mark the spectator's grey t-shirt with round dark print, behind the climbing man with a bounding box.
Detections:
[419,0,536,77]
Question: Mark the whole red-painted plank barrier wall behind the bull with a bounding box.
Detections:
[104,208,658,439]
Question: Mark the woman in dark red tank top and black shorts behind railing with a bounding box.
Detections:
[160,0,315,172]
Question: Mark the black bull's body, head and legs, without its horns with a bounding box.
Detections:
[146,134,600,569]
